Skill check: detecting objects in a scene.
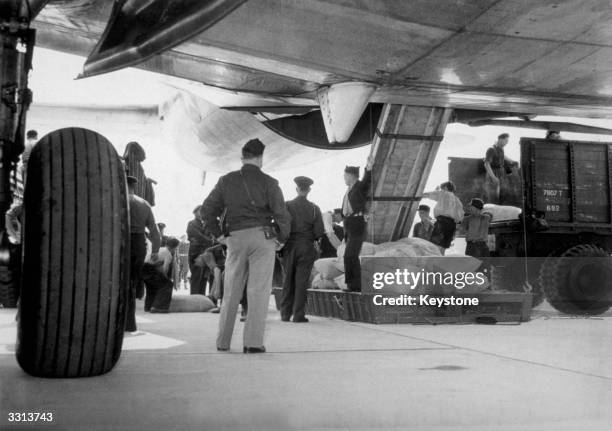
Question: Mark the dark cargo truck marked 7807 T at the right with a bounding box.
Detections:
[449,138,612,315]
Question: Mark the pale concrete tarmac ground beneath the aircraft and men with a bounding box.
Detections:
[0,301,612,431]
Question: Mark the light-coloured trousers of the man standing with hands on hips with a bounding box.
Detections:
[217,227,276,349]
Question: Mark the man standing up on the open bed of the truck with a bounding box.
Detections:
[484,133,518,205]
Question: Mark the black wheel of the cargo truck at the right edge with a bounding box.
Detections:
[540,244,612,315]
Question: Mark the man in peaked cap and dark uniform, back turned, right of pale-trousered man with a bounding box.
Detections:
[280,177,325,323]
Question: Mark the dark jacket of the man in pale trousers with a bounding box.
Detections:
[202,165,291,242]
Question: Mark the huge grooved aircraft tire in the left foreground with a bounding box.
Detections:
[17,128,130,377]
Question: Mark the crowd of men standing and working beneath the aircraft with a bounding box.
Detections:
[127,133,559,353]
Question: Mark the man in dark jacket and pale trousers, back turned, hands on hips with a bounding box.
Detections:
[202,139,291,353]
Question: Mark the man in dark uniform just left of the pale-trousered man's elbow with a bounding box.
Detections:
[187,205,216,295]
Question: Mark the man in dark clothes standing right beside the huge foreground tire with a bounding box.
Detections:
[125,176,161,332]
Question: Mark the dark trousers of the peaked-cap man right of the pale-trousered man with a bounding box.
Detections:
[280,240,317,320]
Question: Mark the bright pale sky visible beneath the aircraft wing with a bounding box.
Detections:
[27,48,612,237]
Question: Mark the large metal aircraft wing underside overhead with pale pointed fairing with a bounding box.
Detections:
[29,0,612,146]
